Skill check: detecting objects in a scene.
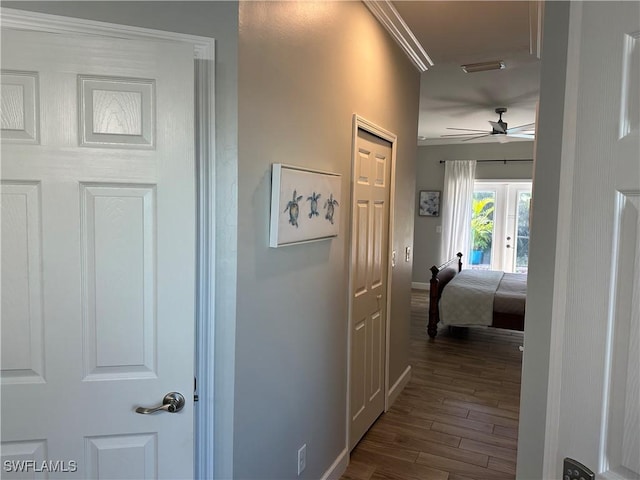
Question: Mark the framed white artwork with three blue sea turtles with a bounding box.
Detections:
[269,163,343,248]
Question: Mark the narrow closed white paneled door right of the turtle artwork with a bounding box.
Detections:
[349,128,392,448]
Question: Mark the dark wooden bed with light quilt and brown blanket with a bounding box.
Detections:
[427,253,527,338]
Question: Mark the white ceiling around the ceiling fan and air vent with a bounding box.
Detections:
[392,0,540,145]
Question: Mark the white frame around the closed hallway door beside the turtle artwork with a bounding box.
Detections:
[345,113,398,455]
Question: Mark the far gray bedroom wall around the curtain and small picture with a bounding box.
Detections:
[413,142,533,283]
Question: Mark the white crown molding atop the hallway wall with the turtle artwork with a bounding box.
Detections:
[362,0,433,72]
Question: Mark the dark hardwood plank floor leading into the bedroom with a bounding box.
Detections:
[341,290,523,480]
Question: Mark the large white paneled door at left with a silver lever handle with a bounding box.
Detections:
[1,28,195,479]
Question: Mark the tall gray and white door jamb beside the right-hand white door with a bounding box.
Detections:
[516,2,582,478]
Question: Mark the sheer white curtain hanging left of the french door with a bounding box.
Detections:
[440,160,476,262]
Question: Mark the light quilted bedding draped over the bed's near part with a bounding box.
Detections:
[440,270,504,326]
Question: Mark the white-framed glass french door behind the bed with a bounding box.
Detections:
[468,181,531,273]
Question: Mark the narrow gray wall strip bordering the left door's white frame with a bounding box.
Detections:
[2,1,238,478]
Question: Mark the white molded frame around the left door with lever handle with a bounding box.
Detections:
[0,8,218,478]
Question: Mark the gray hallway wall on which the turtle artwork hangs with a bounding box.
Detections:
[234,2,419,479]
